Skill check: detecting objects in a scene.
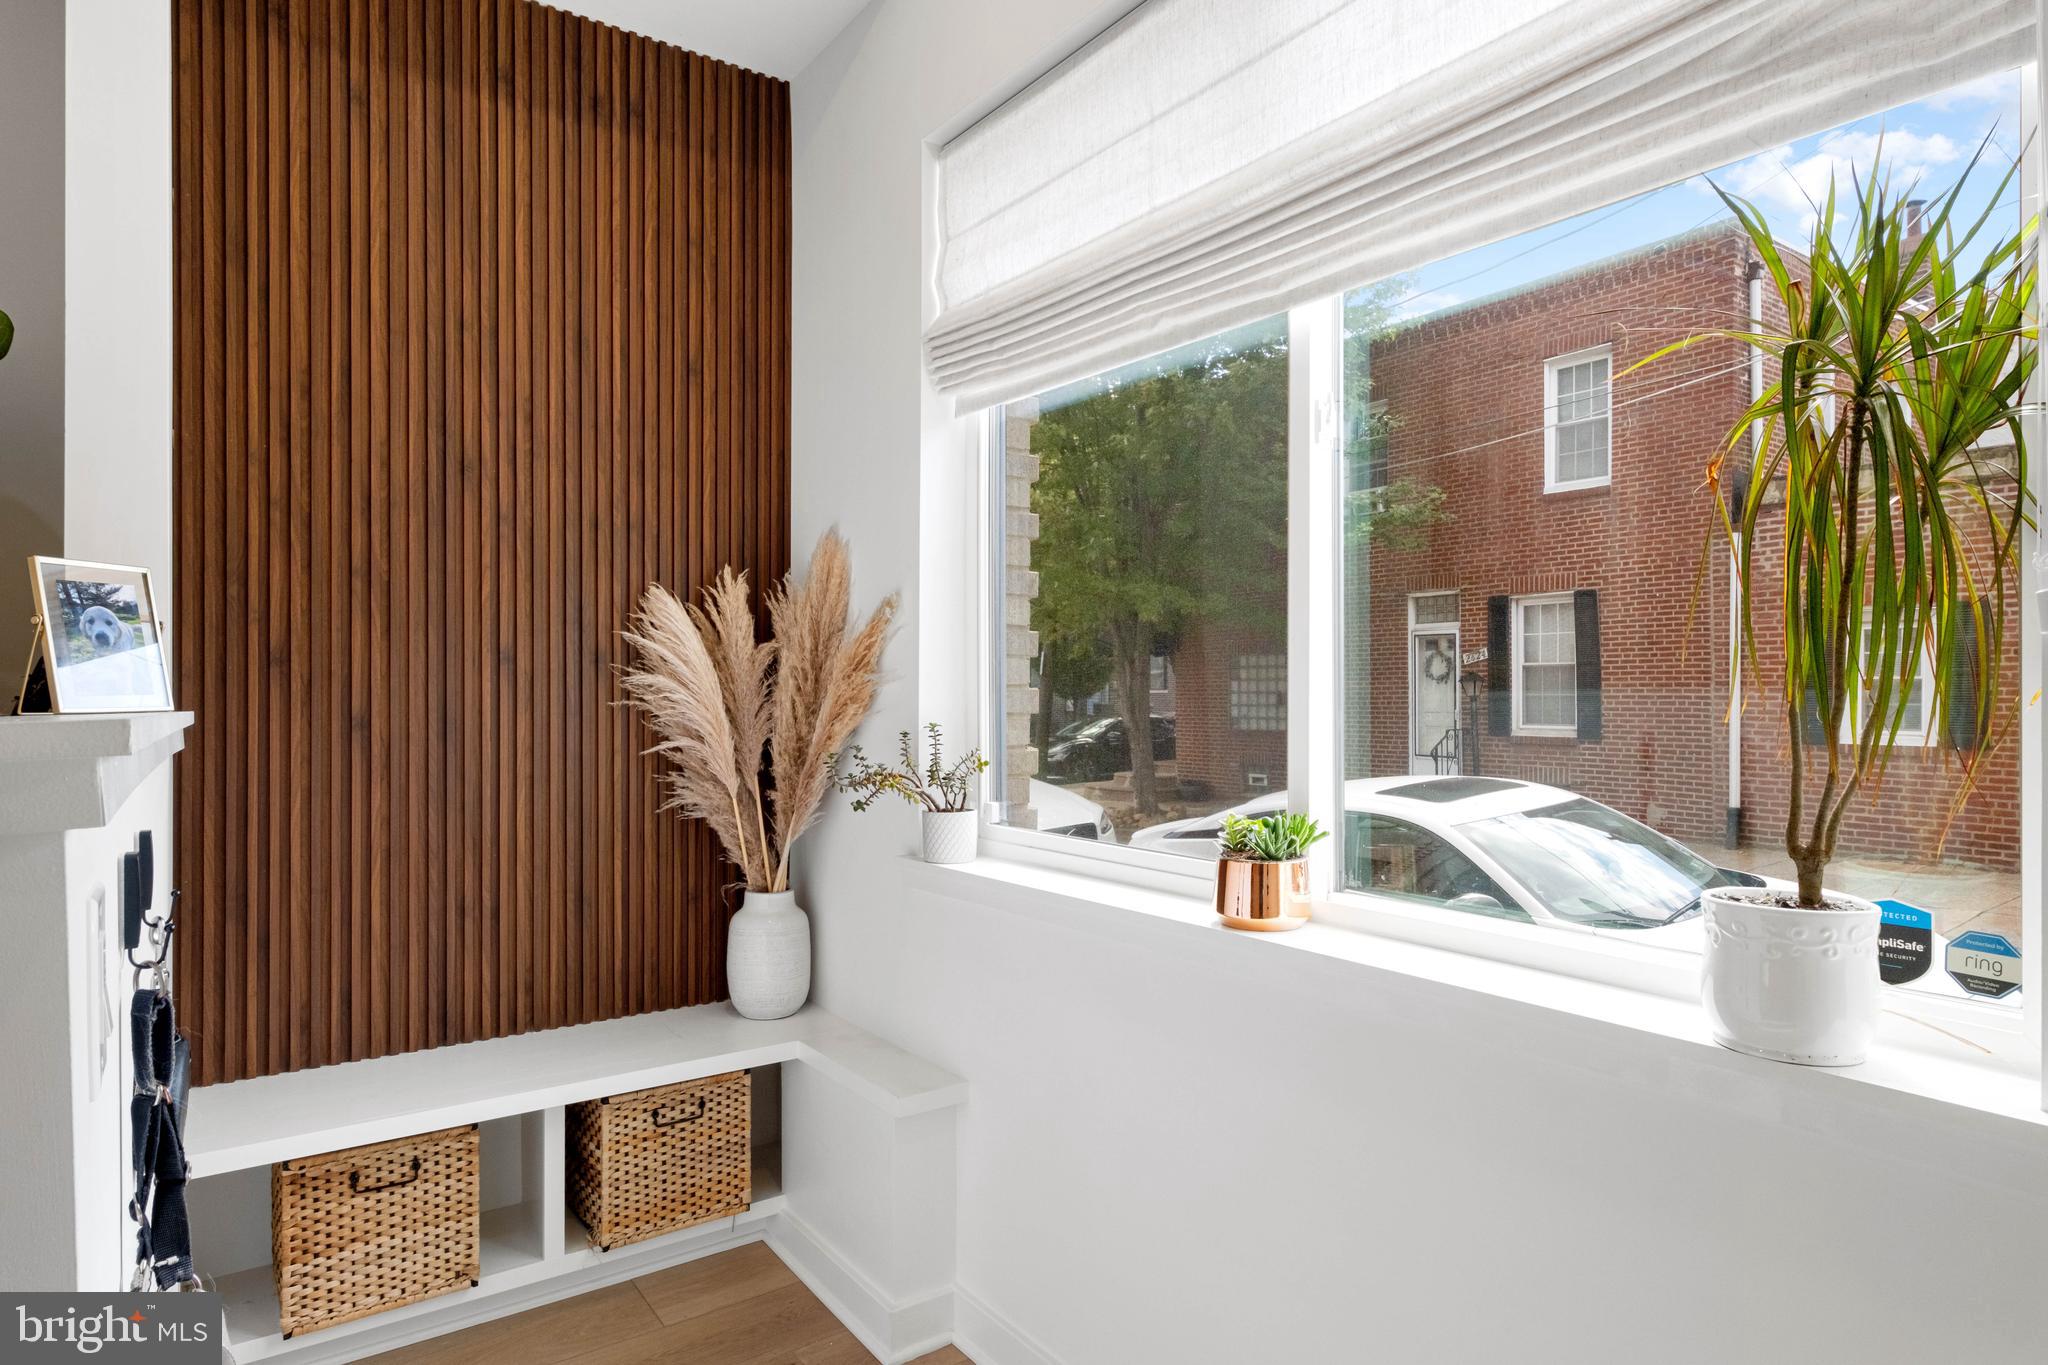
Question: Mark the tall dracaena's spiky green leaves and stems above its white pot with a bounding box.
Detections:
[1640,145,2036,907]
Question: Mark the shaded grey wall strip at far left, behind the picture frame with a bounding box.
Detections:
[0,0,63,699]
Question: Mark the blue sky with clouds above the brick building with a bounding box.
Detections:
[1368,72,2019,317]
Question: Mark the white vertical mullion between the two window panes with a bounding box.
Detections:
[1286,295,1343,898]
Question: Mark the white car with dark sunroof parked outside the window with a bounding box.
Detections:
[1130,776,1964,995]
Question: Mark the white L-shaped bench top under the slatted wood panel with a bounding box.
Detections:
[184,1005,967,1177]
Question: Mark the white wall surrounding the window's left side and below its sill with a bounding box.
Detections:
[793,0,2048,1365]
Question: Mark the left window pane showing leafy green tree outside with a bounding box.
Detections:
[991,317,1288,857]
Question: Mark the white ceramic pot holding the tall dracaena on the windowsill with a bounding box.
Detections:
[1700,888,1878,1066]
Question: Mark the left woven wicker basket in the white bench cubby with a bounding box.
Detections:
[270,1124,477,1336]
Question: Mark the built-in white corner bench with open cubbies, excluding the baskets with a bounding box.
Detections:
[186,1005,967,1365]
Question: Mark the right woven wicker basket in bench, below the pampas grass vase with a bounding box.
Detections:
[567,1070,754,1250]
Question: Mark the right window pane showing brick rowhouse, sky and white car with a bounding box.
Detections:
[1337,78,2038,1005]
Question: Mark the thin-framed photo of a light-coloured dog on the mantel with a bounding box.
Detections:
[23,555,174,714]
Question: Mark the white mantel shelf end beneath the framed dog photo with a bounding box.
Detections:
[0,710,193,837]
